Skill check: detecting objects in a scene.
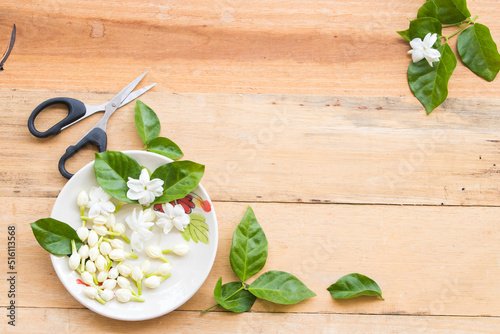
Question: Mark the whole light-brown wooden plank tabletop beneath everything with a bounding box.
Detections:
[0,0,500,333]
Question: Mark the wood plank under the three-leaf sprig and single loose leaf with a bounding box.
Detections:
[0,197,500,316]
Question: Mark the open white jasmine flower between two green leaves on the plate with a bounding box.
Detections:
[127,168,163,206]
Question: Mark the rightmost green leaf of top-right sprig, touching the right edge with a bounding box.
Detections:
[457,23,500,81]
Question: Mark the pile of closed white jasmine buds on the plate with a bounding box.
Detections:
[69,191,189,304]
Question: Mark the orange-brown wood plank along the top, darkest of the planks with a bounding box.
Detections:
[0,0,500,98]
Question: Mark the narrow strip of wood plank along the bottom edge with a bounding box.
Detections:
[0,308,500,334]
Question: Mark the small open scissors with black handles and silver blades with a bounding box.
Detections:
[28,72,155,179]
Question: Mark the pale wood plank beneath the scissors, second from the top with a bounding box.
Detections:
[0,89,500,205]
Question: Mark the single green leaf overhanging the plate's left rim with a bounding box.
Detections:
[30,218,83,255]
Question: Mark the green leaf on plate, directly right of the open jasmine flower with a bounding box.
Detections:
[151,160,205,204]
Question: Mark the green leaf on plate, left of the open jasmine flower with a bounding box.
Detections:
[94,151,142,203]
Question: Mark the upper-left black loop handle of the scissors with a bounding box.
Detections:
[28,97,86,138]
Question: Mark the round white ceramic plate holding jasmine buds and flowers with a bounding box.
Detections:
[51,151,218,321]
